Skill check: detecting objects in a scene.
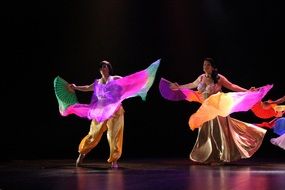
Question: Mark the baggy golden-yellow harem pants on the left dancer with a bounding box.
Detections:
[78,106,125,163]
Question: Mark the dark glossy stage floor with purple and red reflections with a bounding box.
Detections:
[0,159,285,190]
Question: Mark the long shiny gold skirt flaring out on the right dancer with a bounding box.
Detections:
[190,116,266,163]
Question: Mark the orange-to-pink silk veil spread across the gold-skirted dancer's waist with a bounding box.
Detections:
[189,85,273,130]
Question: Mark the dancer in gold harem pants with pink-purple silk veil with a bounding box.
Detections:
[57,60,160,168]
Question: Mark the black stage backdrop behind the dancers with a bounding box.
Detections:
[0,0,285,160]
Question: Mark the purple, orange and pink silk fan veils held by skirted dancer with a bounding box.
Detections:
[159,78,273,130]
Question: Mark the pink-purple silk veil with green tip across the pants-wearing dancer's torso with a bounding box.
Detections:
[57,59,160,122]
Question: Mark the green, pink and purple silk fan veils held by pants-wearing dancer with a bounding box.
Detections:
[54,59,160,122]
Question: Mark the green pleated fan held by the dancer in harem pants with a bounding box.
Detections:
[53,76,78,114]
